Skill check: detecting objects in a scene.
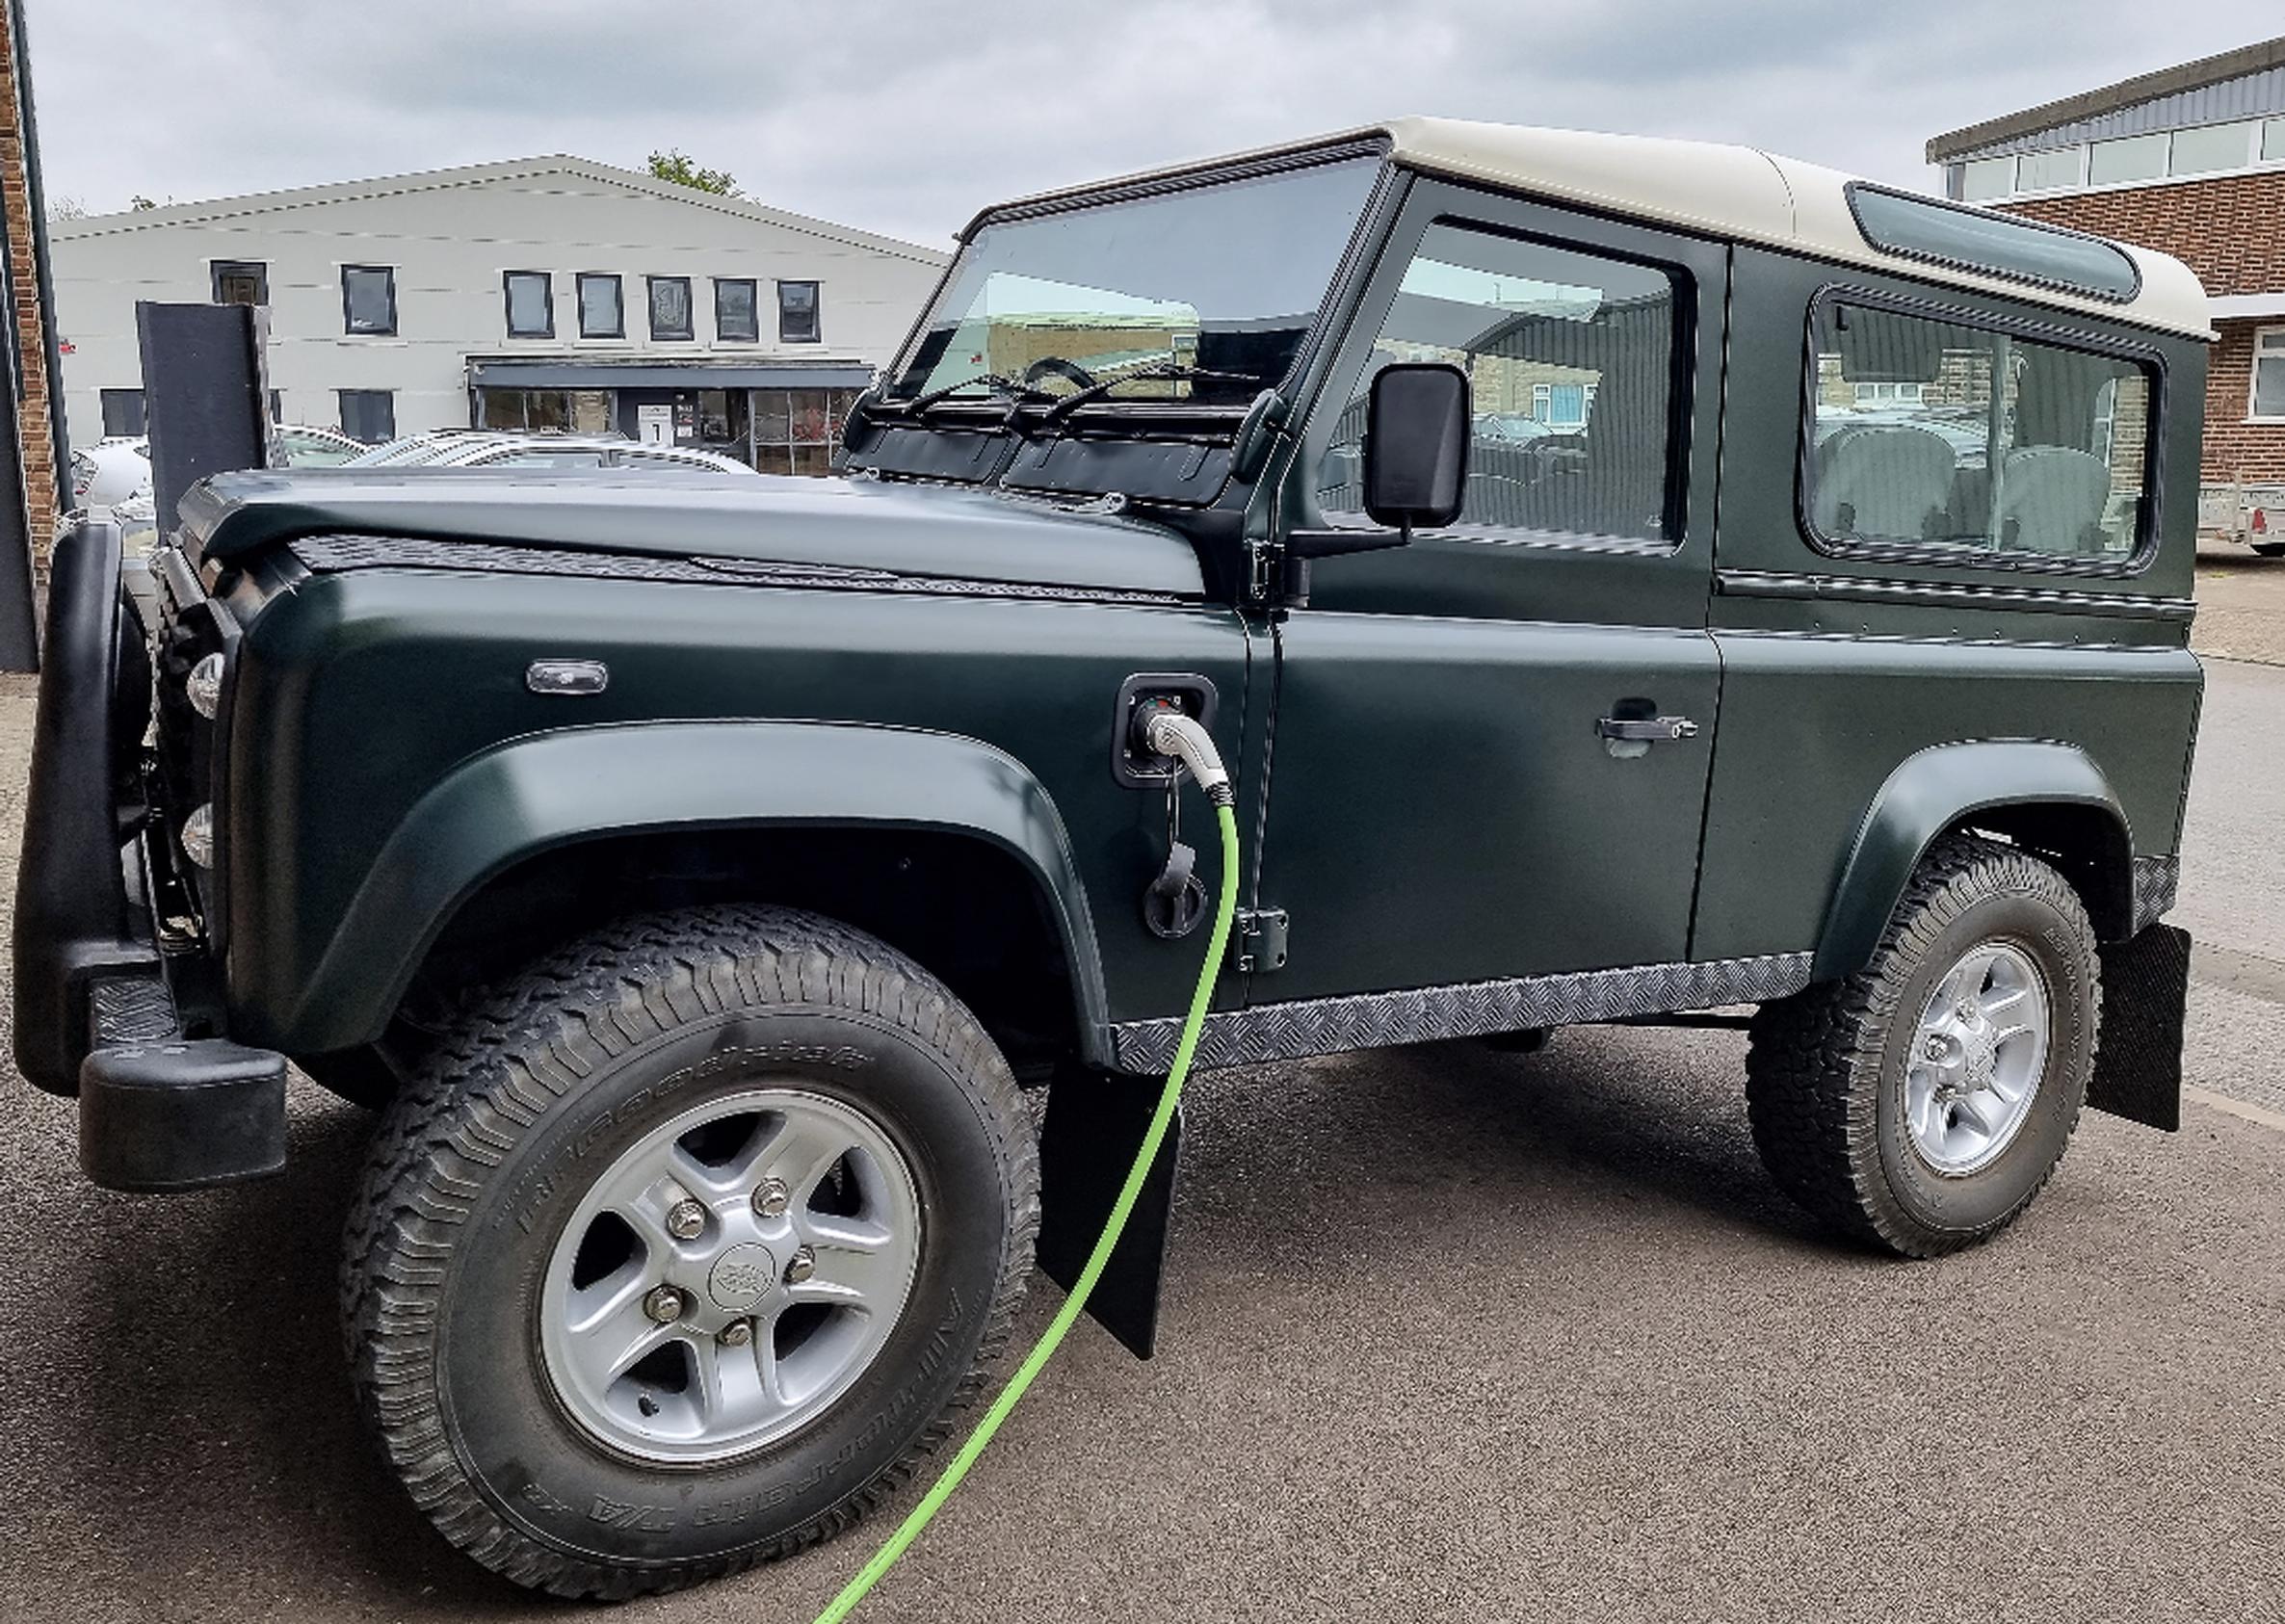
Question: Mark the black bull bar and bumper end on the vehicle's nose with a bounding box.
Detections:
[13,518,286,1190]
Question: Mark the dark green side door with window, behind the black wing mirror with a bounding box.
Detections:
[1248,180,1727,1003]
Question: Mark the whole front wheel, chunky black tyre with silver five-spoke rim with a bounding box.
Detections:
[343,906,1037,1597]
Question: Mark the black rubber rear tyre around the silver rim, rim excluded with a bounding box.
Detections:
[1746,836,2102,1256]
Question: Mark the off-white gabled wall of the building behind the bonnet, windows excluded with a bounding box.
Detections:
[50,158,946,445]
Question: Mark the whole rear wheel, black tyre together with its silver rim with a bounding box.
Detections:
[1746,834,2102,1259]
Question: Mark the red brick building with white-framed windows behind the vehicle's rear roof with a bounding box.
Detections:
[1929,37,2285,485]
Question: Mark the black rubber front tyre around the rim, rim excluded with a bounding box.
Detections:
[343,906,1037,1597]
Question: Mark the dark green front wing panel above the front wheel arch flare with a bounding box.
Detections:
[217,568,1248,1051]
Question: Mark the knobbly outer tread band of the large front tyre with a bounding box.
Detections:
[340,904,1039,1601]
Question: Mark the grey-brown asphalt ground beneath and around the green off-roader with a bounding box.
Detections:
[0,562,2285,1624]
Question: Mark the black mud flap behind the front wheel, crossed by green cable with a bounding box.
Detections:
[1037,1069,1181,1359]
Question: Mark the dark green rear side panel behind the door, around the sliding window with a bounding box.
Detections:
[1691,249,2205,973]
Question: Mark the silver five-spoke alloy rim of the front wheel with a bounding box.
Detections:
[539,1087,921,1462]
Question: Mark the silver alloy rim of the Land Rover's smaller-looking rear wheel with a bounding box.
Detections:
[1904,941,2054,1176]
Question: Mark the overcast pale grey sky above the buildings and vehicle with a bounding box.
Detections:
[25,0,2280,245]
